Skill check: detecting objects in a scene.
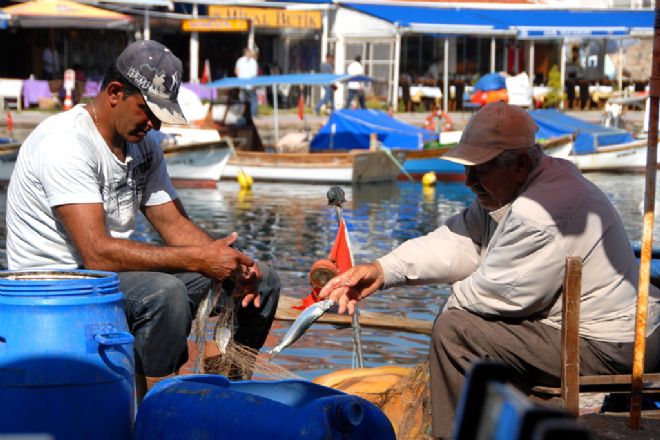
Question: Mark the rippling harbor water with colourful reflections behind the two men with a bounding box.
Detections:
[0,174,660,379]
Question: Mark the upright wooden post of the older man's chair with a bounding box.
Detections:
[561,257,582,416]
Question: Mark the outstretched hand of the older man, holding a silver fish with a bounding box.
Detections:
[319,262,385,315]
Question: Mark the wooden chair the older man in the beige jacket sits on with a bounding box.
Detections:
[531,257,660,416]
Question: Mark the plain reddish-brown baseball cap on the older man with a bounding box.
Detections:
[442,101,539,166]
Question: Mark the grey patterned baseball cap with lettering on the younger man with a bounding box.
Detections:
[115,40,186,124]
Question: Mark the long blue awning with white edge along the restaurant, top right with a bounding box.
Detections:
[342,3,654,39]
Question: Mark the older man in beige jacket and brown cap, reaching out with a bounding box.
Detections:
[319,102,660,438]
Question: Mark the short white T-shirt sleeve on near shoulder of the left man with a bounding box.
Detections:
[35,132,103,207]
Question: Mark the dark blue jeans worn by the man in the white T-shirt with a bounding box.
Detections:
[118,263,280,377]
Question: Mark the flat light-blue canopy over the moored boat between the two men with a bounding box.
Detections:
[206,73,373,89]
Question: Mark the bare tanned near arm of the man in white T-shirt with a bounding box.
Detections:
[55,203,253,280]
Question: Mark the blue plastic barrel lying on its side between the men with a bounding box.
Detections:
[134,375,395,440]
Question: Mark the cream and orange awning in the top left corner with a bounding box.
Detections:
[2,0,133,29]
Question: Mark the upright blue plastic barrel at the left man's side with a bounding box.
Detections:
[0,271,135,440]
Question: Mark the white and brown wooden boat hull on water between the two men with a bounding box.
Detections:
[222,150,405,184]
